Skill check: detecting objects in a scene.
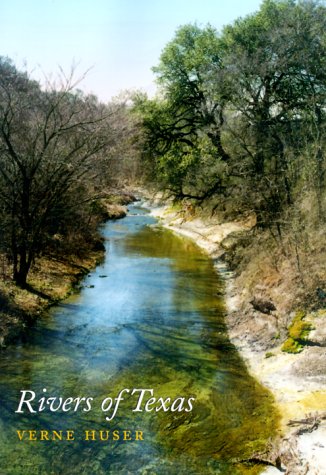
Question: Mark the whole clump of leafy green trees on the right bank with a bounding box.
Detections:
[136,0,326,232]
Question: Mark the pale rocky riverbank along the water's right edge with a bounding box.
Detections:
[149,201,326,475]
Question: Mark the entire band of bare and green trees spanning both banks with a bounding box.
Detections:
[0,0,326,285]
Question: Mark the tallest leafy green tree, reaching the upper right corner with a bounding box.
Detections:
[221,0,326,218]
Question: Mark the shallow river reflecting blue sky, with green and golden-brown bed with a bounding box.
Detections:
[0,206,277,475]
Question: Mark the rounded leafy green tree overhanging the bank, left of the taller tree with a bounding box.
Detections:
[138,25,229,200]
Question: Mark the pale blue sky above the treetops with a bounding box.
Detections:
[0,0,261,102]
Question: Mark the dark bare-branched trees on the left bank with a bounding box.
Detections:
[0,58,119,286]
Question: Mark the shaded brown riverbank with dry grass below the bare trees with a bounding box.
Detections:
[0,191,136,349]
